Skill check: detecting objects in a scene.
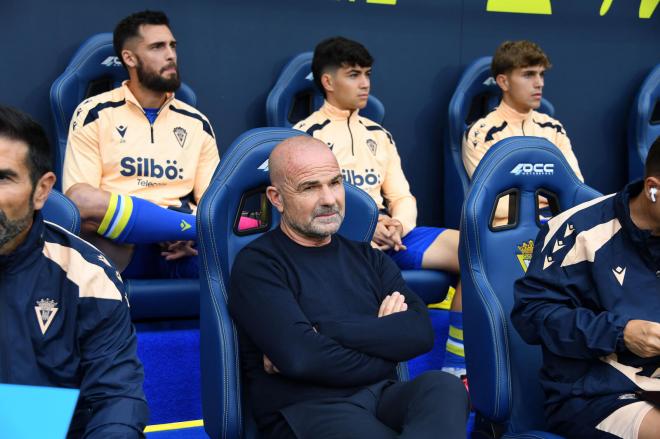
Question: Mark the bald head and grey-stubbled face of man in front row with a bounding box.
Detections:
[269,139,345,245]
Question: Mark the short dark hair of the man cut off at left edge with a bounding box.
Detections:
[0,105,53,187]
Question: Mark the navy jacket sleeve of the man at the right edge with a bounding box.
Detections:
[511,226,629,359]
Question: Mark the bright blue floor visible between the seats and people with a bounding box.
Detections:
[136,309,473,439]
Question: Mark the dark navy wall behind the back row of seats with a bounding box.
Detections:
[0,0,660,225]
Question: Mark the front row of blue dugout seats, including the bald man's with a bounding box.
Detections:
[44,128,600,439]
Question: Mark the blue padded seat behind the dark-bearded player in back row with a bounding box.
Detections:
[50,32,199,320]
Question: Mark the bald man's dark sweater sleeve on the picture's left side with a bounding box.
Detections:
[229,248,395,387]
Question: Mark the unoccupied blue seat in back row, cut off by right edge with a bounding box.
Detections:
[628,64,660,181]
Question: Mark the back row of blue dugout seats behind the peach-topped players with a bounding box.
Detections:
[50,33,660,319]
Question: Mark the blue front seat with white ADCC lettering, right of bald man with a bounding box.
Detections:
[459,137,600,438]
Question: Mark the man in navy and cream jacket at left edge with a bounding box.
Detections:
[0,106,149,439]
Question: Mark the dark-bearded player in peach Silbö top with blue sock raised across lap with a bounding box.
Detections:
[63,11,220,277]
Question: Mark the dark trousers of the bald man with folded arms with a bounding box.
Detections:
[266,371,469,439]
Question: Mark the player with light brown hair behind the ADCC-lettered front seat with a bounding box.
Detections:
[461,40,584,225]
